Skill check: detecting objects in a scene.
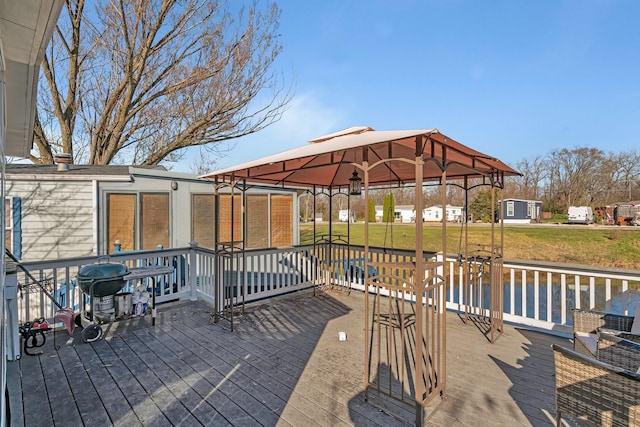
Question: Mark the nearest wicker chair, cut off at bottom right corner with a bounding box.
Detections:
[552,344,640,427]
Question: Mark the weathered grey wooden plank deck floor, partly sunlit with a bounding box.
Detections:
[7,292,569,427]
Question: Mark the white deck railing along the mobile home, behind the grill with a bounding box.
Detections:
[16,246,320,323]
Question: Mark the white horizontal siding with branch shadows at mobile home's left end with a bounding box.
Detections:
[7,177,94,261]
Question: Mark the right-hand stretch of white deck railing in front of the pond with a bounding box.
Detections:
[318,244,640,336]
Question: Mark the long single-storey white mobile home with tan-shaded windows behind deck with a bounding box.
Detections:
[5,164,299,261]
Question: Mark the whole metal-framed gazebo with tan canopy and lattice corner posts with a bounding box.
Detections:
[204,127,518,425]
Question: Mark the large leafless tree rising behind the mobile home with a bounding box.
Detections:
[31,0,290,165]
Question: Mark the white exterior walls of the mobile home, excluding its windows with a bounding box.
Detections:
[6,165,299,261]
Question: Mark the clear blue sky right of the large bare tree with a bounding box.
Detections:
[174,0,640,171]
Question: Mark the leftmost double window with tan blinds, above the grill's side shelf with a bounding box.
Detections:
[106,193,170,252]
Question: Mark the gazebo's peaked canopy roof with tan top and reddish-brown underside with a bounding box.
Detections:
[203,127,519,188]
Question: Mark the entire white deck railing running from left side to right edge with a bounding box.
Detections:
[8,243,640,335]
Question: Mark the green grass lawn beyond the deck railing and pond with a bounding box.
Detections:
[300,223,640,269]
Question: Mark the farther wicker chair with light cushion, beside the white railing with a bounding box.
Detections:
[572,308,640,357]
